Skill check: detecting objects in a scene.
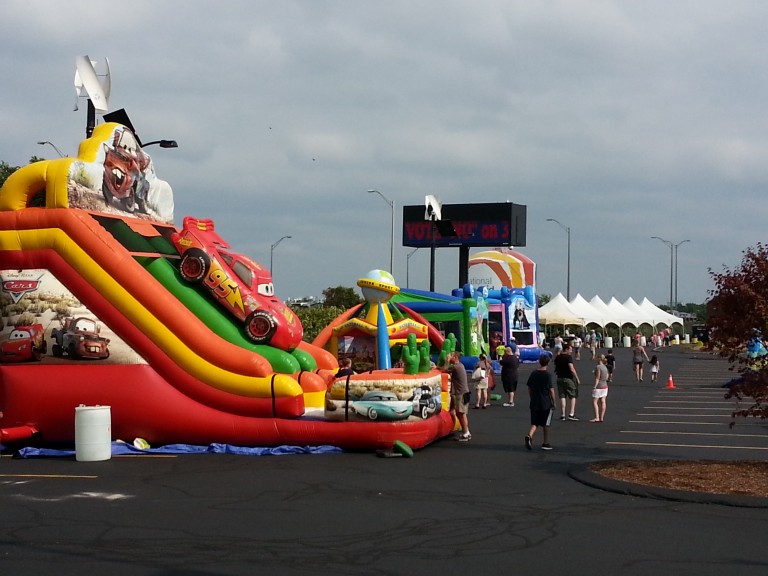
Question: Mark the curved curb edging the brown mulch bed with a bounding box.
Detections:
[568,461,768,508]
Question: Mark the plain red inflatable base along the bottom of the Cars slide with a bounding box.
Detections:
[0,364,453,450]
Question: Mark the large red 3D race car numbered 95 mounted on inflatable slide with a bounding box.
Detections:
[171,216,304,351]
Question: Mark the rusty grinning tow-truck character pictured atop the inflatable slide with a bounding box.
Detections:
[101,129,149,212]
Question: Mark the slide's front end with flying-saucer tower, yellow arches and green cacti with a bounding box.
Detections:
[313,270,456,433]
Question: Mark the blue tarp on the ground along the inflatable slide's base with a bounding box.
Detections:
[18,440,343,458]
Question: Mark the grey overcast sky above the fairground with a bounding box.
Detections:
[0,0,768,304]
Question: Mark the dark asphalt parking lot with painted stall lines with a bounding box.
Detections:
[0,347,768,576]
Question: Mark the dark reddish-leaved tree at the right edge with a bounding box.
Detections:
[707,244,768,418]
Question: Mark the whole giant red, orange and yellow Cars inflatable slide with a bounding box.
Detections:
[0,122,453,450]
